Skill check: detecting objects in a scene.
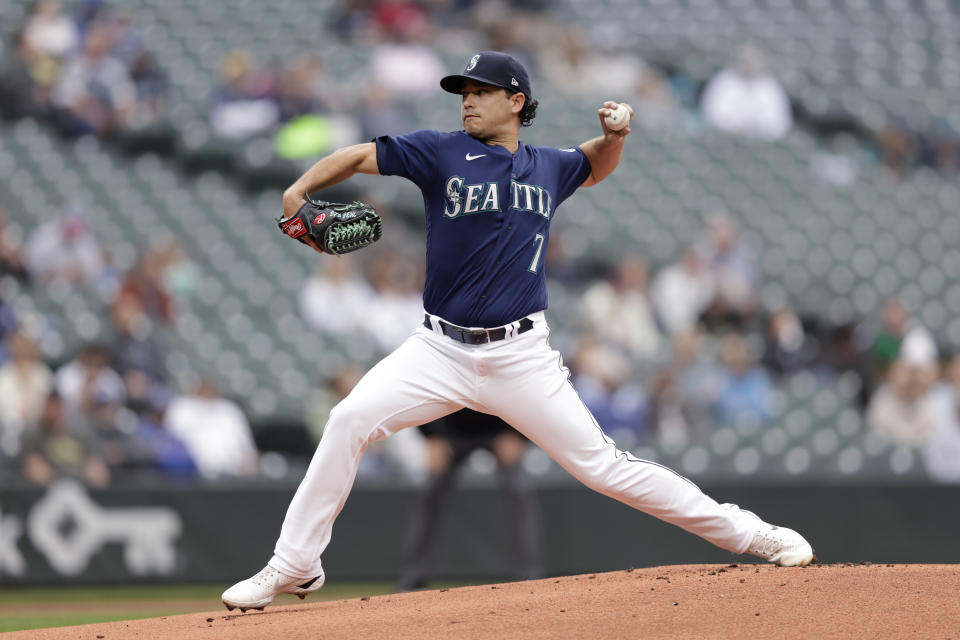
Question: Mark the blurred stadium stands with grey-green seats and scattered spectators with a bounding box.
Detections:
[0,0,960,487]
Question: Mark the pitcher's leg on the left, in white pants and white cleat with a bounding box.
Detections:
[223,328,473,610]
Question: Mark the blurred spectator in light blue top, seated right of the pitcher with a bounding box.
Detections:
[713,333,774,424]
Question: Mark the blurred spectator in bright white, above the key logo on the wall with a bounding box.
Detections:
[164,379,258,478]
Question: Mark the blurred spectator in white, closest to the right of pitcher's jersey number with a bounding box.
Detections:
[580,254,660,358]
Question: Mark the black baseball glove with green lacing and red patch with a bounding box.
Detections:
[277,194,383,255]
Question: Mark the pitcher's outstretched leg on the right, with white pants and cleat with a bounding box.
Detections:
[480,323,813,565]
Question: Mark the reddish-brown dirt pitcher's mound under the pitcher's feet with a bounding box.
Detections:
[4,564,960,640]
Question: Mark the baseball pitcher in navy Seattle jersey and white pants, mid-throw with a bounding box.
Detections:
[223,51,814,611]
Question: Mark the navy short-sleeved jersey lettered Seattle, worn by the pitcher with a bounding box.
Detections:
[376,130,590,327]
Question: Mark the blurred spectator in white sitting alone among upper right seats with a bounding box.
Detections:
[701,44,793,140]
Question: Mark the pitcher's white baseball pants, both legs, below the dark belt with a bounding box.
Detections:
[269,312,760,579]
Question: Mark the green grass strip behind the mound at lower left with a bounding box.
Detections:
[0,582,402,633]
